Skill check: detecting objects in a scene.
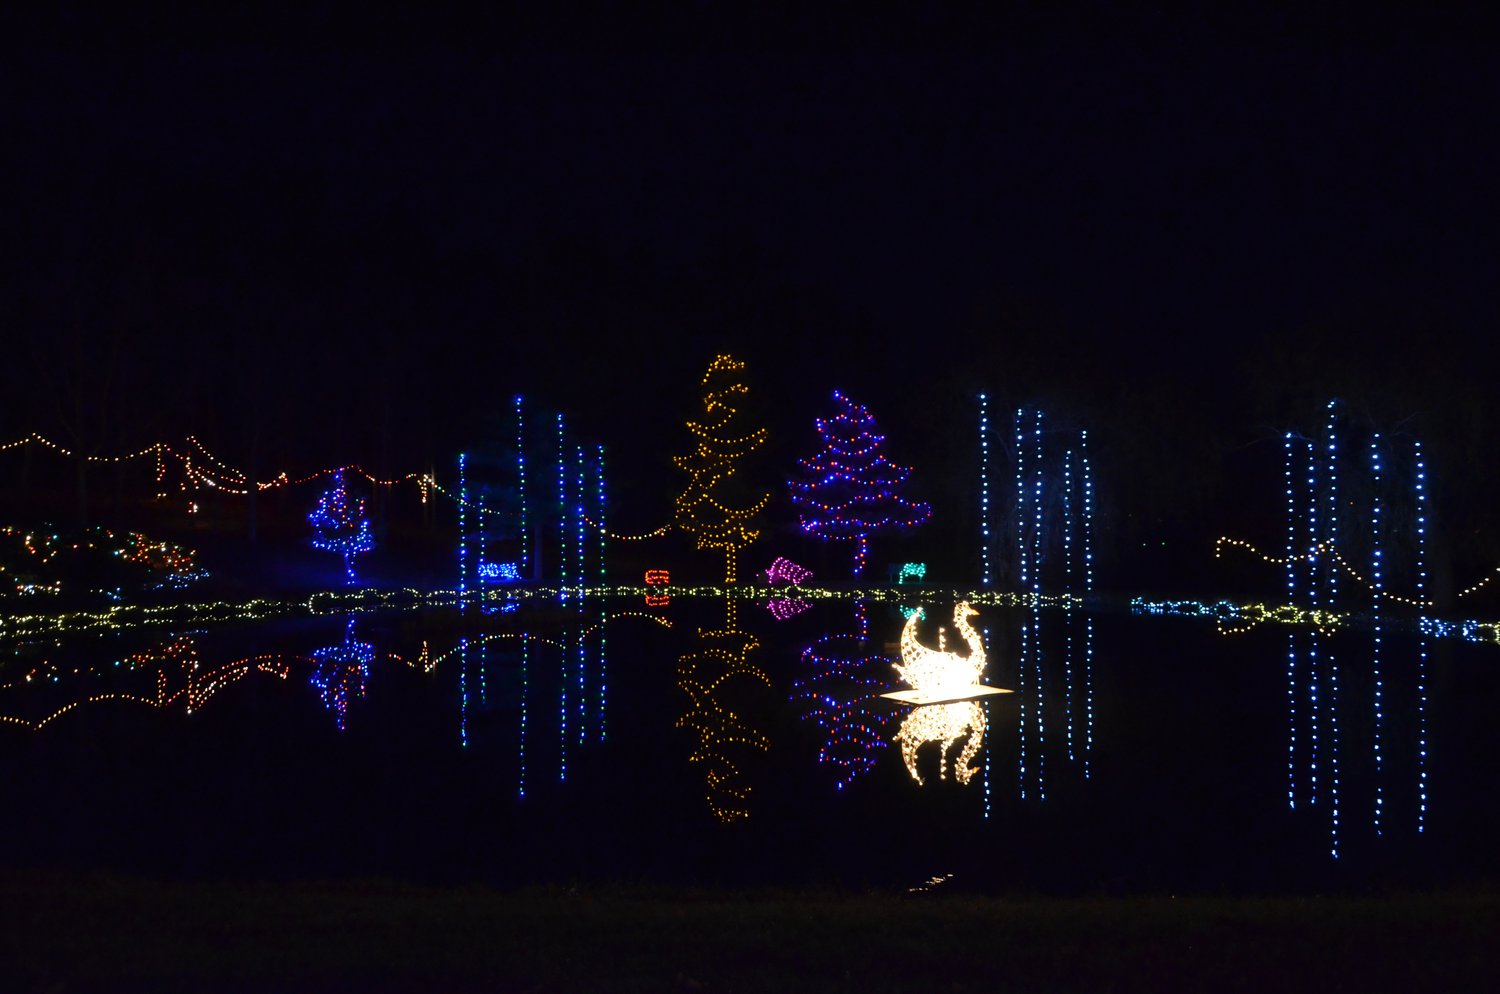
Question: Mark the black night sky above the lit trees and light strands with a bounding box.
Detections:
[0,4,1500,551]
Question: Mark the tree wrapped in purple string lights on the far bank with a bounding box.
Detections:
[788,390,932,577]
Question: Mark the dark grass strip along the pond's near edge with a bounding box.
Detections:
[0,873,1500,994]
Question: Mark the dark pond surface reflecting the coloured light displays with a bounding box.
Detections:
[0,601,1500,894]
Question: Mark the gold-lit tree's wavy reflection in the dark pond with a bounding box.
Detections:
[677,630,771,822]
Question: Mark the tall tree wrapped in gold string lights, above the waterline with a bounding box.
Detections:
[672,355,771,593]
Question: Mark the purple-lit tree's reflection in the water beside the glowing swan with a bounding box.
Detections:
[792,636,888,790]
